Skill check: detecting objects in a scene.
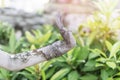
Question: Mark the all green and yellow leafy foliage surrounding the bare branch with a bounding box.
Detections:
[0,0,120,80]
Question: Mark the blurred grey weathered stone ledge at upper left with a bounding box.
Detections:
[0,8,53,30]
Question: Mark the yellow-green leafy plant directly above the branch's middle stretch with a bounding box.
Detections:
[25,25,60,48]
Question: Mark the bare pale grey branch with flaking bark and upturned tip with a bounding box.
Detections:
[0,16,76,71]
